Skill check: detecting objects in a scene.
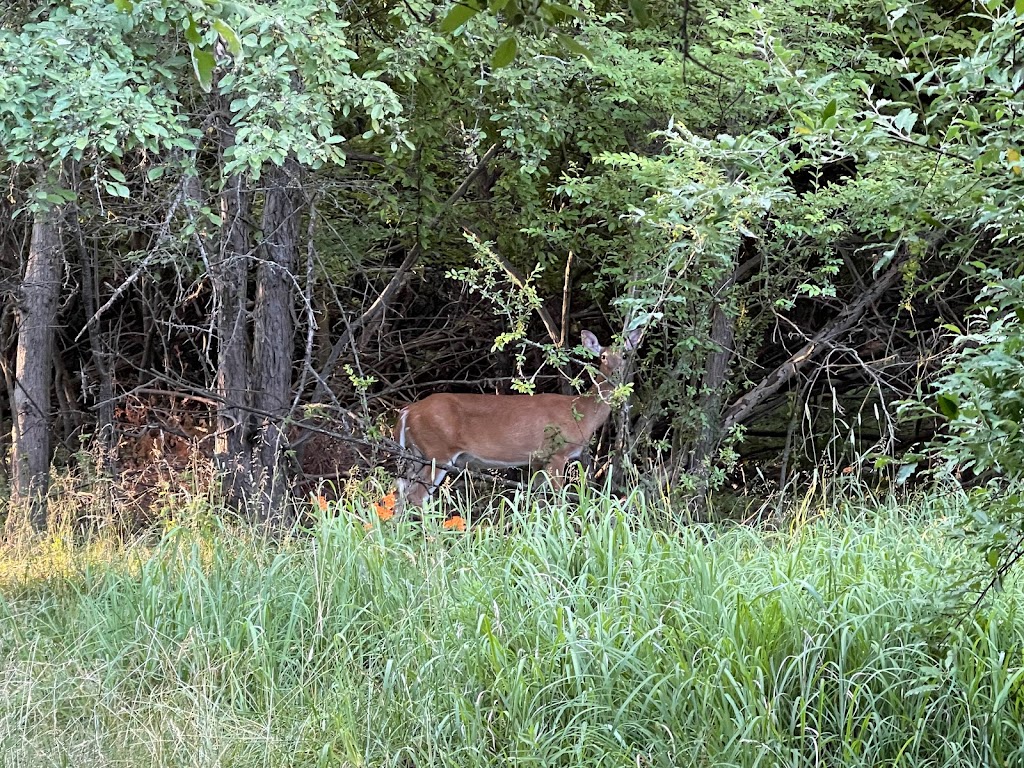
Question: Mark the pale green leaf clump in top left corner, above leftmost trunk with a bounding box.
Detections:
[0,0,192,167]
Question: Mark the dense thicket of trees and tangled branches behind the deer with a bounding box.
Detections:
[0,0,1024,524]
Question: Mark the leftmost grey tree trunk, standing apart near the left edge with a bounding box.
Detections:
[11,201,63,530]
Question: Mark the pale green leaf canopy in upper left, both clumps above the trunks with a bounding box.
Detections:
[0,0,406,177]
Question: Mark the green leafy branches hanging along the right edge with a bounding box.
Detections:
[850,5,1024,587]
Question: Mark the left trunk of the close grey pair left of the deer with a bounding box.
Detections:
[210,126,252,507]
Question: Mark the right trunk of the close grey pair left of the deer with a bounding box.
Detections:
[253,159,302,522]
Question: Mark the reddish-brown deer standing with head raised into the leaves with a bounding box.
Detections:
[398,331,639,505]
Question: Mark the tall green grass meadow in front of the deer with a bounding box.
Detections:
[0,487,1024,768]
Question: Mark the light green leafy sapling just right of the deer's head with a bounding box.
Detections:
[599,127,786,460]
